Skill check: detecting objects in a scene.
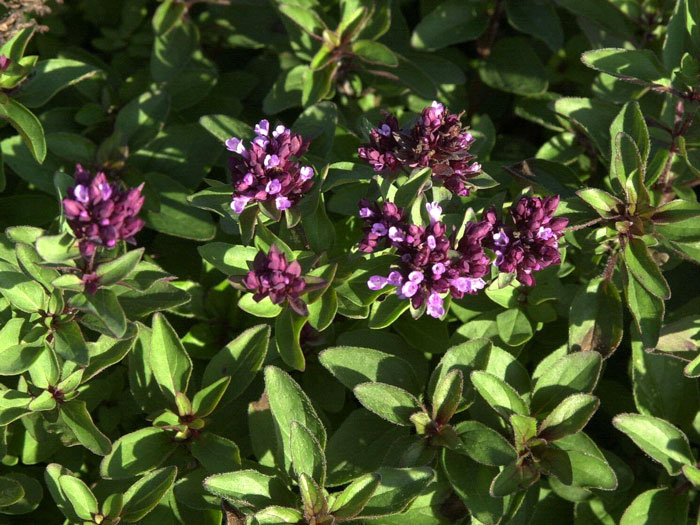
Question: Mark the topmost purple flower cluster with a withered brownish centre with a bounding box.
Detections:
[358,102,481,197]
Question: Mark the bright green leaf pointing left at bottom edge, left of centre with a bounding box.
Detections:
[204,470,293,508]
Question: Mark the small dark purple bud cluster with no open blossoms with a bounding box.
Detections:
[242,244,308,316]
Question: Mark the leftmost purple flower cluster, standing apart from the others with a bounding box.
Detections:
[63,164,144,259]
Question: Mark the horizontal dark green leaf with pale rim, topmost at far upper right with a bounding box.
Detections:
[581,48,671,86]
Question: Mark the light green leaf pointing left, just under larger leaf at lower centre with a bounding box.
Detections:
[353,383,423,426]
